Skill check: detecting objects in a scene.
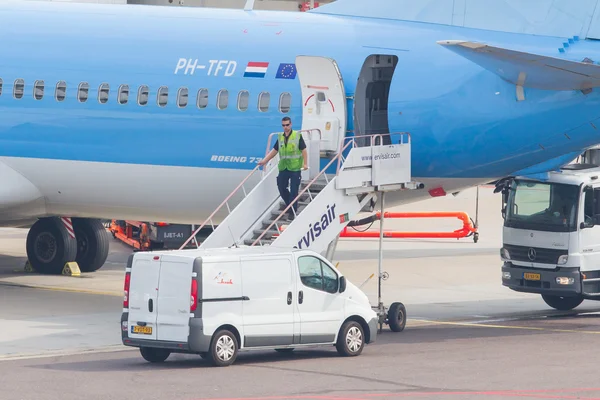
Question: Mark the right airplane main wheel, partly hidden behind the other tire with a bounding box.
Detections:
[72,218,110,272]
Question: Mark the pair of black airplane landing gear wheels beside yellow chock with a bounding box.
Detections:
[26,217,109,275]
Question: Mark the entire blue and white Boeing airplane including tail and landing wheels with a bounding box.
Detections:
[0,0,600,273]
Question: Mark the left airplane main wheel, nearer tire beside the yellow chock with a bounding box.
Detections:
[26,217,77,274]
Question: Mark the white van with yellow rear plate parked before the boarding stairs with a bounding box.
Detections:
[121,246,378,366]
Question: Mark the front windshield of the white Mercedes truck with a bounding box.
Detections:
[504,180,579,232]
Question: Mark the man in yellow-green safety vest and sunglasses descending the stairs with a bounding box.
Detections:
[258,117,308,221]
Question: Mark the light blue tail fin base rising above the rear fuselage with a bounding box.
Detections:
[310,0,600,39]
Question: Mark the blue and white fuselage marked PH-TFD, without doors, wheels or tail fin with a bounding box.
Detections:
[0,2,600,225]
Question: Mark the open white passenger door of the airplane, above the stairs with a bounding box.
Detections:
[296,56,347,159]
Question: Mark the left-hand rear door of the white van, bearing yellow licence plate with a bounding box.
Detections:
[128,253,160,339]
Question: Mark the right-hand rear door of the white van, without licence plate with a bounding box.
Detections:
[157,254,194,342]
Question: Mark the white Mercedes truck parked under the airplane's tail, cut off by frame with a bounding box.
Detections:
[497,164,600,310]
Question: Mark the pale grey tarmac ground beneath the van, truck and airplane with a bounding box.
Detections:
[0,188,600,400]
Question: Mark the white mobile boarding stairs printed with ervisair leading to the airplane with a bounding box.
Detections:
[181,129,422,253]
